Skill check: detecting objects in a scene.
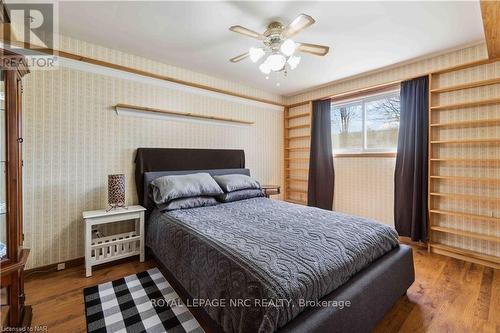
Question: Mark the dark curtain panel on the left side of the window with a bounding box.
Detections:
[307,99,335,210]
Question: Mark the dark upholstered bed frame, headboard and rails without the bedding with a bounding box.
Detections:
[136,148,415,333]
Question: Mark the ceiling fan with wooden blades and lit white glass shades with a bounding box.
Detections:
[229,14,330,75]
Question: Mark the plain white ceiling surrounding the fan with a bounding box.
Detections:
[48,1,484,95]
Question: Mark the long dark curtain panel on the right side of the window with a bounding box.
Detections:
[394,76,429,241]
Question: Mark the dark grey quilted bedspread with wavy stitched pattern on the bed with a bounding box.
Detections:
[146,198,399,333]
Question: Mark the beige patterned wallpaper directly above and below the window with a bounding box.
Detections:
[285,44,488,226]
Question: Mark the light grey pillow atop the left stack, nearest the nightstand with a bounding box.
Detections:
[151,173,224,205]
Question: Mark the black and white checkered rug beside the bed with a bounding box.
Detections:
[83,268,203,333]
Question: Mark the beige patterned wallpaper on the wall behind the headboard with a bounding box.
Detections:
[24,39,283,268]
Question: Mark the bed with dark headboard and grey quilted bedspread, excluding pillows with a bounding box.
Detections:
[136,148,414,332]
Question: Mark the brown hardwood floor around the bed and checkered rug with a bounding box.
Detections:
[25,247,500,333]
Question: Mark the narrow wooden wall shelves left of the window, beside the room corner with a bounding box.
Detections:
[284,103,312,205]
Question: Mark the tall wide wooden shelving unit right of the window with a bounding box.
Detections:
[428,60,500,268]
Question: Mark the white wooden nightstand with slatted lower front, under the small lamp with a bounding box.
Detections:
[83,206,146,277]
